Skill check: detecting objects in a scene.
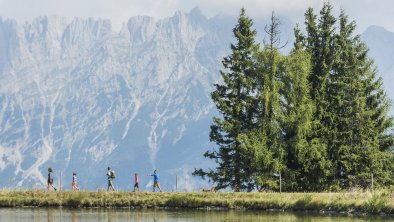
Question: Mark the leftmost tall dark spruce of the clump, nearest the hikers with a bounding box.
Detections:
[194,8,258,191]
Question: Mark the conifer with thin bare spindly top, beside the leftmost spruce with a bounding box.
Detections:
[242,13,285,190]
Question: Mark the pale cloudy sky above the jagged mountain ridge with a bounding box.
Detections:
[0,0,394,33]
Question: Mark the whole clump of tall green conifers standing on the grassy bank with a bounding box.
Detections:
[194,3,394,191]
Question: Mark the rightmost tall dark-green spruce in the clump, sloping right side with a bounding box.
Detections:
[329,10,393,188]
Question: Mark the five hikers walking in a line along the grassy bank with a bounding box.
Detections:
[47,167,162,192]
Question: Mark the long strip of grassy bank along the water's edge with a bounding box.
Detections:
[0,190,394,214]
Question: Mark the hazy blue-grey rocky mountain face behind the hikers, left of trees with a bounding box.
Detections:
[0,9,233,189]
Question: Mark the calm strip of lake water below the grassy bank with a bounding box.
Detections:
[0,208,394,222]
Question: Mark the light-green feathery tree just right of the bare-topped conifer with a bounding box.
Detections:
[281,47,330,191]
